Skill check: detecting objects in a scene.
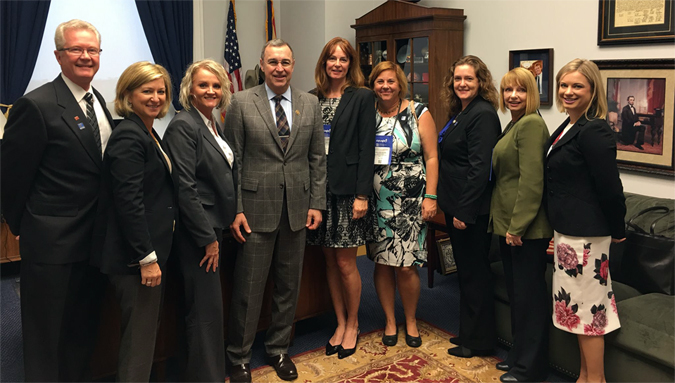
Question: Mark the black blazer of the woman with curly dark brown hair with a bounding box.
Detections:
[438,96,501,224]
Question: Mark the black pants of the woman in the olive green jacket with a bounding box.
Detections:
[499,237,551,382]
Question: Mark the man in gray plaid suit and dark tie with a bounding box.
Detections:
[225,39,326,382]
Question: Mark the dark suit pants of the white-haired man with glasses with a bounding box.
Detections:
[20,259,105,382]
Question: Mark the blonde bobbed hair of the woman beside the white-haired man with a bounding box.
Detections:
[115,61,171,118]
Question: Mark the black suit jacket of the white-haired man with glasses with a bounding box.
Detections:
[0,75,115,264]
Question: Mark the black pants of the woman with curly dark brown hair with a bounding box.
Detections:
[445,214,496,351]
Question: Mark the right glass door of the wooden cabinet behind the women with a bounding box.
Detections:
[395,37,429,104]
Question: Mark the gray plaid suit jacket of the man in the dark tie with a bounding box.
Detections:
[225,84,326,232]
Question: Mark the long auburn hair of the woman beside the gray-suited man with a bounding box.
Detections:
[314,37,365,98]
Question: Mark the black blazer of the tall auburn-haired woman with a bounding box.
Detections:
[310,87,375,195]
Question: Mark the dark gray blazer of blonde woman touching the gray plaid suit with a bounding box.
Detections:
[163,107,237,247]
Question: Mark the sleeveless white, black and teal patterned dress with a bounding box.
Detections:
[368,103,427,267]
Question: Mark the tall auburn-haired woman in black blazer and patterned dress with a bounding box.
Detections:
[307,37,375,359]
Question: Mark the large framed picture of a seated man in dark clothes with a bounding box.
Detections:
[594,59,675,176]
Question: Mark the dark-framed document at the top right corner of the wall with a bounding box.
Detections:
[598,0,675,45]
